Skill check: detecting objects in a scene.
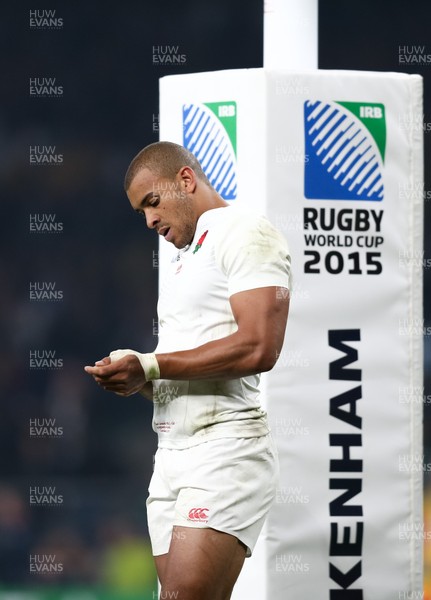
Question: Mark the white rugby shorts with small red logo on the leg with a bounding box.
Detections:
[147,434,278,556]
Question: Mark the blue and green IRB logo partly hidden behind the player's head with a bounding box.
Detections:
[183,102,237,200]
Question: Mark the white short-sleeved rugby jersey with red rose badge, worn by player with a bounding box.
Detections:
[153,206,290,448]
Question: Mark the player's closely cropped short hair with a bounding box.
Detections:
[124,142,211,192]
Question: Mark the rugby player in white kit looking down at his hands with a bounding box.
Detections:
[85,142,290,600]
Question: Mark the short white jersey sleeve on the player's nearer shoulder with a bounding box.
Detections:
[215,214,290,297]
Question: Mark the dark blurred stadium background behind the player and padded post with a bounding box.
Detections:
[0,0,431,600]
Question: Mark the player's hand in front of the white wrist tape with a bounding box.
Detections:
[84,354,147,396]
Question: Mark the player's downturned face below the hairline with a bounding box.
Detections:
[127,169,196,248]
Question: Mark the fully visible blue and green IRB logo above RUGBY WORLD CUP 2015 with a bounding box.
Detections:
[304,100,386,201]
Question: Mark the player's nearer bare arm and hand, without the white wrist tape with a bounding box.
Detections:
[85,287,289,398]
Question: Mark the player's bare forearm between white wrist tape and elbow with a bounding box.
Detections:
[156,332,281,380]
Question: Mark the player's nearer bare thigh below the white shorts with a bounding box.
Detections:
[162,526,246,600]
